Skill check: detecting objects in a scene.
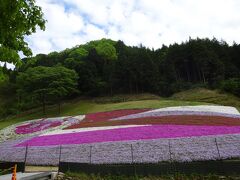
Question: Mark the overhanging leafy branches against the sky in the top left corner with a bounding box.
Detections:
[0,0,46,65]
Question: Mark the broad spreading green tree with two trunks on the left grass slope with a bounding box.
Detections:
[17,66,78,114]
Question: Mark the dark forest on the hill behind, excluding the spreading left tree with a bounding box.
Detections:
[0,38,240,116]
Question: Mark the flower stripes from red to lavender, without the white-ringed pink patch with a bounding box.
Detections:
[0,106,240,165]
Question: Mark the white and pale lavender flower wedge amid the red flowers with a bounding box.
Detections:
[111,105,240,120]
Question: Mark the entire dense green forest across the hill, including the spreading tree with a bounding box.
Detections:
[0,38,240,116]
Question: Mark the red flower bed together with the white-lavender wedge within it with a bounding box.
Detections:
[65,106,240,129]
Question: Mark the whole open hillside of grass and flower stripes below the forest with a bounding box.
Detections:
[0,89,240,177]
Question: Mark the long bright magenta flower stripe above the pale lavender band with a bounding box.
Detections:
[17,125,240,146]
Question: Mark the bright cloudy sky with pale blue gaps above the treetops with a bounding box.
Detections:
[27,0,240,54]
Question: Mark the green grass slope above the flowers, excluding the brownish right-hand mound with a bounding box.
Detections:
[0,94,207,129]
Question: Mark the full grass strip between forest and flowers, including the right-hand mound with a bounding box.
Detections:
[0,89,240,129]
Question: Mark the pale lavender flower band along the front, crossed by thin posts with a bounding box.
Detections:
[0,134,240,165]
